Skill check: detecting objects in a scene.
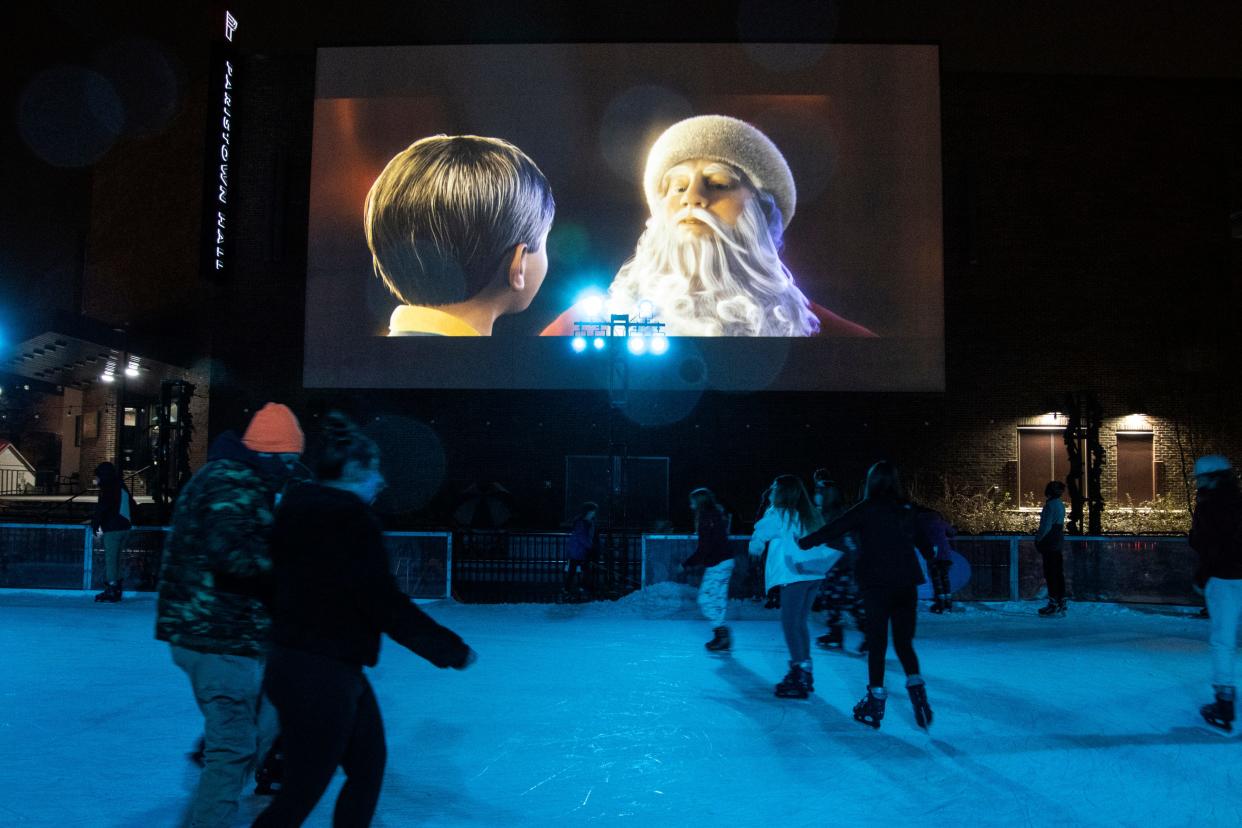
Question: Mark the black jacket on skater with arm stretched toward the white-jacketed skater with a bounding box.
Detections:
[797,497,933,588]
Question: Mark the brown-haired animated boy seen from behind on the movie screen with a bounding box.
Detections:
[363,135,556,336]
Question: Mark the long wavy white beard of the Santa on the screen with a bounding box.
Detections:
[609,200,820,336]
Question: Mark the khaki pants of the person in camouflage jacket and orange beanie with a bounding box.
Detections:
[171,644,277,828]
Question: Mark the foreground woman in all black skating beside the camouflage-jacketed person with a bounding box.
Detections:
[255,412,474,827]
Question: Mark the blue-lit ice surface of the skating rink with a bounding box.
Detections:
[0,585,1227,828]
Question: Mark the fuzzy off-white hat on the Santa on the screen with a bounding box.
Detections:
[642,115,797,227]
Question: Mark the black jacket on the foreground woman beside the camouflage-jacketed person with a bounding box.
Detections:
[272,483,469,667]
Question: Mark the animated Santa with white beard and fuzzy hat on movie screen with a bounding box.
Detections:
[543,115,874,336]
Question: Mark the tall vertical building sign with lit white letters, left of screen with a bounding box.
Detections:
[202,4,240,281]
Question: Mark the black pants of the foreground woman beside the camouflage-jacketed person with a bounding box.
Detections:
[255,648,388,828]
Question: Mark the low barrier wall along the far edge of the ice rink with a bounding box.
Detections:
[0,523,1202,606]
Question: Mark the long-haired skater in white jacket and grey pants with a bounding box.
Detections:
[749,474,841,699]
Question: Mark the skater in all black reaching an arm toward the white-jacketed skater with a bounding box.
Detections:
[797,461,932,729]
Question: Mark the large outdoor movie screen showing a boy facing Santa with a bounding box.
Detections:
[304,43,944,391]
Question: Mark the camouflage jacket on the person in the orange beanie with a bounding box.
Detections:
[155,432,295,655]
